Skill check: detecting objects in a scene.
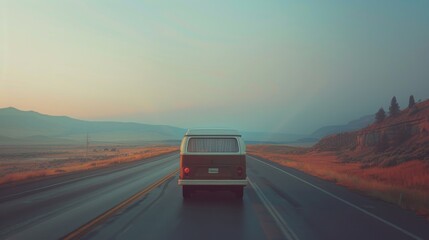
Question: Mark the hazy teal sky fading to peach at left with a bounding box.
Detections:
[0,0,429,134]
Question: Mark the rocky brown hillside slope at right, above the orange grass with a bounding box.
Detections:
[314,100,429,166]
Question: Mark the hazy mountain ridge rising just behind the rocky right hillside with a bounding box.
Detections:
[311,114,374,138]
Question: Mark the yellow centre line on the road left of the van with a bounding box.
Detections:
[63,169,179,240]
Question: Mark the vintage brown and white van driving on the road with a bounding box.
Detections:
[179,129,247,199]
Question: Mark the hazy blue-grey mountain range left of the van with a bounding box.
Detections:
[0,107,185,145]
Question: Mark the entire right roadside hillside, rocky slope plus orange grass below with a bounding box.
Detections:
[247,100,429,216]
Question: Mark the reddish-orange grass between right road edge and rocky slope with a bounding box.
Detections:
[247,145,429,217]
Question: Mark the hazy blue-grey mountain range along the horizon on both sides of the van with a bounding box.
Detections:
[0,107,373,145]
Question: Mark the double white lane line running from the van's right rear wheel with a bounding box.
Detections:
[248,178,299,240]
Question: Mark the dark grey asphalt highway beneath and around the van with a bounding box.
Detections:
[0,154,429,240]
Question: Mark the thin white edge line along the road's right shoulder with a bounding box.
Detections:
[249,156,423,240]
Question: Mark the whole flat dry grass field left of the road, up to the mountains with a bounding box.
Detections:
[0,145,179,184]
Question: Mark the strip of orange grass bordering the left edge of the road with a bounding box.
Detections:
[0,146,179,184]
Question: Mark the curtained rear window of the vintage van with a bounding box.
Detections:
[188,138,238,152]
